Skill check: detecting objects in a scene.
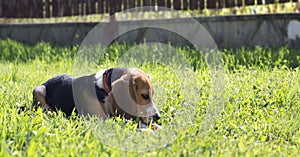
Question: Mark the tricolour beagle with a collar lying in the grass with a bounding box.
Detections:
[33,68,161,130]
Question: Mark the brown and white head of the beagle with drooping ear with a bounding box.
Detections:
[109,69,160,124]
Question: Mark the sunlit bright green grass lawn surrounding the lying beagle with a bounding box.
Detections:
[0,40,300,157]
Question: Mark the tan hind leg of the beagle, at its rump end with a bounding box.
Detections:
[32,85,52,111]
